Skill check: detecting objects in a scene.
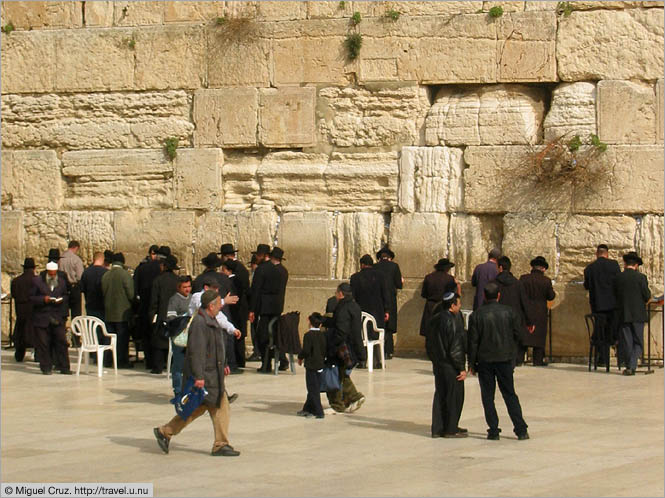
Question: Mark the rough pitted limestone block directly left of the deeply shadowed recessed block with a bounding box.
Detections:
[318,86,430,147]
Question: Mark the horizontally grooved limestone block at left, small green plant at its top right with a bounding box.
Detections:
[62,149,174,210]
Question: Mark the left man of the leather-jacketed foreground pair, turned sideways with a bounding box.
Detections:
[425,292,469,438]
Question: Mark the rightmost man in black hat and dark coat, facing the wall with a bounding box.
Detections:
[615,251,651,375]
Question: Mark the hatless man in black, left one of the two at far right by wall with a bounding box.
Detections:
[584,244,621,365]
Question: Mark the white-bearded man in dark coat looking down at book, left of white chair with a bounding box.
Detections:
[30,261,72,375]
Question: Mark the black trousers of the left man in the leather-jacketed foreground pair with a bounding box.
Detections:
[432,365,464,436]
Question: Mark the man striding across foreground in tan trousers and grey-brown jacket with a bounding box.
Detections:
[153,290,240,456]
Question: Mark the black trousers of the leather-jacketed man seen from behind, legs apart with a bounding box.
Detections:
[478,361,528,436]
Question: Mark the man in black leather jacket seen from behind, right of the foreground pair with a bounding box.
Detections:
[469,282,529,440]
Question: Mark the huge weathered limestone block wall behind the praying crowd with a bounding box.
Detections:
[1,1,663,356]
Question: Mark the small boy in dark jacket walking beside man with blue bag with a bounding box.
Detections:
[297,312,326,418]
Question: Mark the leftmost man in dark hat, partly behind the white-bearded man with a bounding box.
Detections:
[10,258,35,361]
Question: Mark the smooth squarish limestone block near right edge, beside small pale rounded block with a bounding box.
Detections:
[596,80,656,144]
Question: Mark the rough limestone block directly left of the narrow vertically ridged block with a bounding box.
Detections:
[324,152,399,212]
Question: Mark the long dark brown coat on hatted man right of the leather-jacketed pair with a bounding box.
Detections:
[520,270,556,348]
